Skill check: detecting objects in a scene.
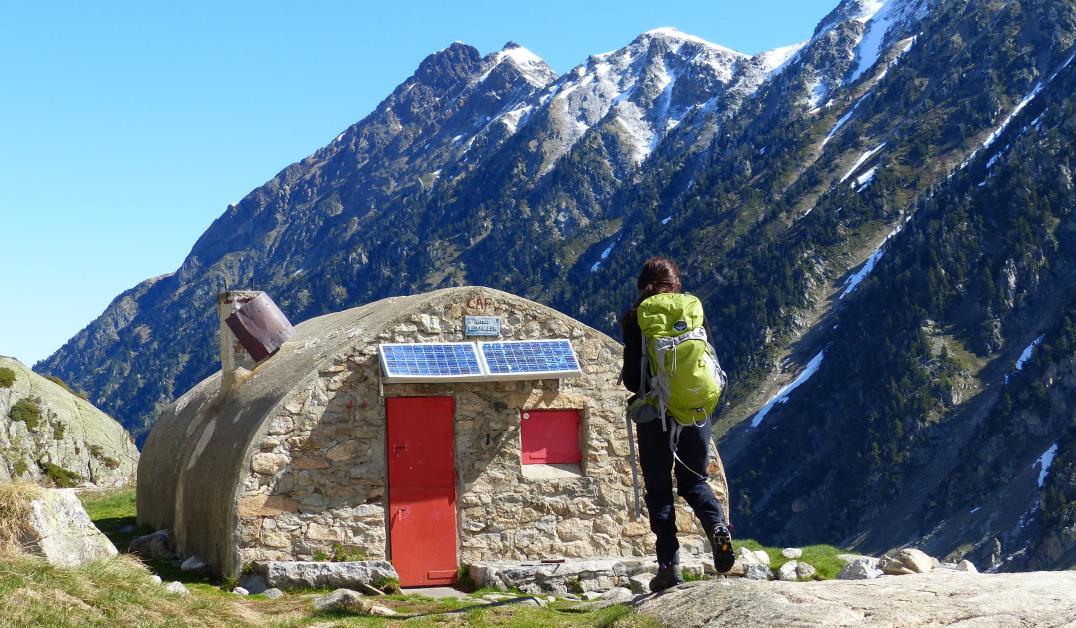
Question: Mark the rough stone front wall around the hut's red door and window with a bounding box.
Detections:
[238,291,723,565]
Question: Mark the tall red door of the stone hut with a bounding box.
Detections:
[386,397,457,586]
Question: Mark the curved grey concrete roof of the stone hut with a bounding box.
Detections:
[138,287,613,573]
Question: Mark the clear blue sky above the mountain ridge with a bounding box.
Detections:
[0,0,837,363]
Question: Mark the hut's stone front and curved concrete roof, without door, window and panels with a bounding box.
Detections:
[138,287,723,574]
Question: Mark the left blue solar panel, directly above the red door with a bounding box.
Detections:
[378,342,486,384]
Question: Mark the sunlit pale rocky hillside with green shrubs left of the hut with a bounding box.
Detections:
[0,356,138,488]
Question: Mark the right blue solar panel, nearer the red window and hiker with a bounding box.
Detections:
[479,339,583,380]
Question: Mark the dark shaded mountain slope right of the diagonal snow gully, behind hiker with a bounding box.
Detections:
[726,2,1076,569]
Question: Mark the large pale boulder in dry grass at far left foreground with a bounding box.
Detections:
[19,488,118,567]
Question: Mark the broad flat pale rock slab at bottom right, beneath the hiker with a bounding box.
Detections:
[638,570,1076,628]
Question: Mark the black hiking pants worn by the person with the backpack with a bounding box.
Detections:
[635,419,725,562]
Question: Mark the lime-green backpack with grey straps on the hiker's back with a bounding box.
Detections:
[629,292,725,426]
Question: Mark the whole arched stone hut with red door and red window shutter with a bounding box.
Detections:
[138,287,724,586]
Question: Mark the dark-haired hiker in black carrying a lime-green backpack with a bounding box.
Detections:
[621,257,735,591]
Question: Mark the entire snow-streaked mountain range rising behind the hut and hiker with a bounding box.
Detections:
[38,0,1076,568]
